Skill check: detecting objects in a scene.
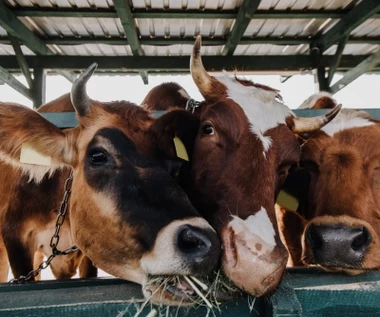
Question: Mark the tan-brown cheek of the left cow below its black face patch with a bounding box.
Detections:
[70,191,144,284]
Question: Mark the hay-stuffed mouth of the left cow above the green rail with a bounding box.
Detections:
[143,271,242,309]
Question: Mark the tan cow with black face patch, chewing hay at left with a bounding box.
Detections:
[0,64,220,304]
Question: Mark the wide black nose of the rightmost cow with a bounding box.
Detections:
[306,225,372,268]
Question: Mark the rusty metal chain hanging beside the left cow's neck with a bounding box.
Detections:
[9,170,79,284]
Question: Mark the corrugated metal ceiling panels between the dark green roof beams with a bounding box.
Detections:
[0,0,380,69]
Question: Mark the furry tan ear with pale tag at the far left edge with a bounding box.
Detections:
[0,103,75,175]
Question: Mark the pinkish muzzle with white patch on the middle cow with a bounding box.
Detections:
[221,208,287,296]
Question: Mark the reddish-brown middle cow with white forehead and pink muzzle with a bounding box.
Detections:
[143,37,338,296]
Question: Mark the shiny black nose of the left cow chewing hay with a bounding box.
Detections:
[177,225,221,274]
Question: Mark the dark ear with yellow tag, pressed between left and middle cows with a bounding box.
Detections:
[150,110,199,160]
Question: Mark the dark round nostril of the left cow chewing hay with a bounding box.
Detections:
[177,226,211,254]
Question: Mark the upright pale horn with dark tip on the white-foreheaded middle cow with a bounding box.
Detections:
[190,35,212,96]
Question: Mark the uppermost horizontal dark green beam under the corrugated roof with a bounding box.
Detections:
[12,7,380,19]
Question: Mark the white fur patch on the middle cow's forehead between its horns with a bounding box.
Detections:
[216,73,294,151]
